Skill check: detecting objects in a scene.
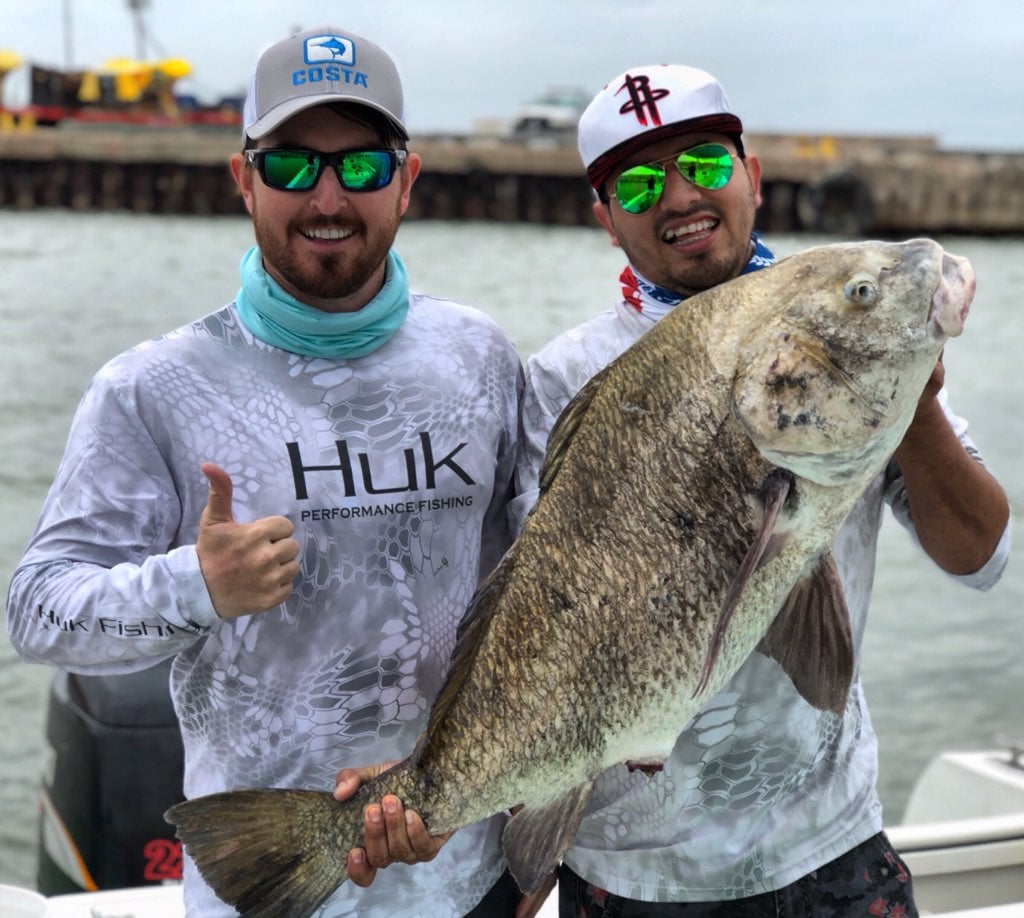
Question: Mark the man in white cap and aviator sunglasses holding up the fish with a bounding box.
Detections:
[513,66,1010,918]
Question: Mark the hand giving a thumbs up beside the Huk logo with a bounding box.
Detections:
[196,462,299,619]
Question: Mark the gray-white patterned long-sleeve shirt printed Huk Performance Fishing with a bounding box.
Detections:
[8,294,522,918]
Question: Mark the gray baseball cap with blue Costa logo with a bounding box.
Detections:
[243,27,409,140]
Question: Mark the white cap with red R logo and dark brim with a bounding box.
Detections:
[578,64,743,189]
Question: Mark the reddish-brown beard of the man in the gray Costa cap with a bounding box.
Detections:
[253,209,399,300]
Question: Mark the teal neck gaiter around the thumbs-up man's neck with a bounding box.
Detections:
[234,246,409,360]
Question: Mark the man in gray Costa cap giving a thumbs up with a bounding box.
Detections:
[7,28,522,918]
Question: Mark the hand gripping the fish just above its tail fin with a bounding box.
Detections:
[334,762,453,886]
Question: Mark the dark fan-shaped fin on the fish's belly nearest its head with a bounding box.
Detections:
[757,552,853,714]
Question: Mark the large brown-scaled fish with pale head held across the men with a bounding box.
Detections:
[167,240,974,916]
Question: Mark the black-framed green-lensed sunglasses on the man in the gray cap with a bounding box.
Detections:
[246,150,407,192]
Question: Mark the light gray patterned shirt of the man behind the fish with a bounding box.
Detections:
[513,302,1009,902]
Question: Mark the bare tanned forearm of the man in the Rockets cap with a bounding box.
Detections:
[895,399,1010,575]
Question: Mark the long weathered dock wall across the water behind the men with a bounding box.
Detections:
[0,123,1024,237]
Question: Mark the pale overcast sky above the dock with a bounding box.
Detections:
[0,0,1024,152]
